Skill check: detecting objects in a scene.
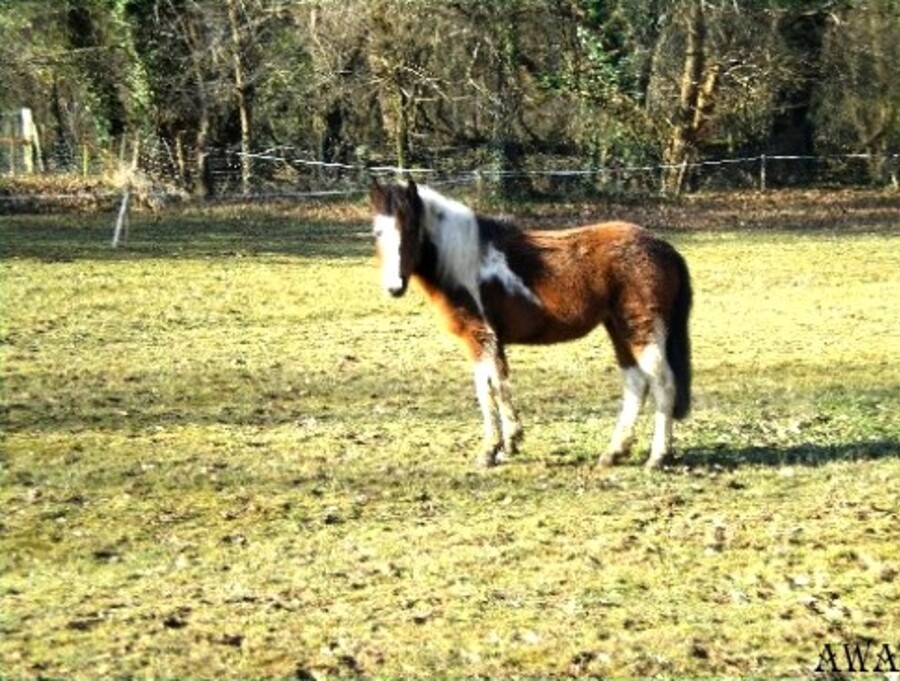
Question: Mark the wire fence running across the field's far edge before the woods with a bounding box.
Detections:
[0,132,900,212]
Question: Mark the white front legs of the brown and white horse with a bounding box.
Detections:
[475,342,522,466]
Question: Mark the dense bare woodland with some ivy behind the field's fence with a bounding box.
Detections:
[0,0,900,196]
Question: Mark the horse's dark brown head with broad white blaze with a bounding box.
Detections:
[369,179,424,297]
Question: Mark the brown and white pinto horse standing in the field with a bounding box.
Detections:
[369,179,693,469]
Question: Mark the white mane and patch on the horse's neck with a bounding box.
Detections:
[418,185,484,311]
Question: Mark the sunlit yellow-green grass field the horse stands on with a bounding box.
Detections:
[0,195,900,679]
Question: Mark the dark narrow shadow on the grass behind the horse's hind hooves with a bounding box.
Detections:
[673,439,900,470]
